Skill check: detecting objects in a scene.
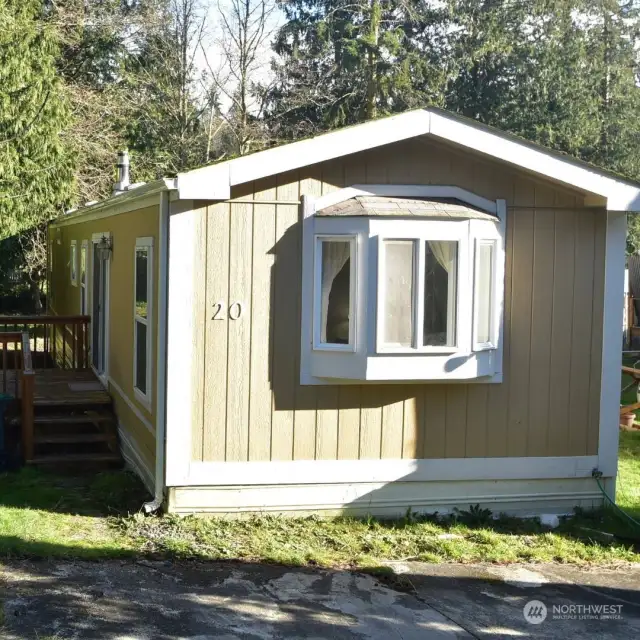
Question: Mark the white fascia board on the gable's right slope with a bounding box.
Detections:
[430,113,640,211]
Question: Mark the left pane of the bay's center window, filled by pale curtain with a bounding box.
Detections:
[383,240,414,347]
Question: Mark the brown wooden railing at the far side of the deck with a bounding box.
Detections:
[0,316,91,370]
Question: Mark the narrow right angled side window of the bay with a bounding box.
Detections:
[474,240,496,350]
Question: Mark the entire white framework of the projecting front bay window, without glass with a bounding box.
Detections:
[300,184,507,386]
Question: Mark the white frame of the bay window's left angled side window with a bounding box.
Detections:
[313,233,358,351]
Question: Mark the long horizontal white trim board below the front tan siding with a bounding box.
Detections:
[167,458,598,486]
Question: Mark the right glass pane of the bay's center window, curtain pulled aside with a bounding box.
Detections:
[423,240,458,347]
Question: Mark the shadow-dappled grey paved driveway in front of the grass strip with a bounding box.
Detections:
[0,560,640,640]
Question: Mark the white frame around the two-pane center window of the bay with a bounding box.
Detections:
[371,218,469,354]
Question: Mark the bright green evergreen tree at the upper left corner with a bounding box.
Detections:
[0,0,73,239]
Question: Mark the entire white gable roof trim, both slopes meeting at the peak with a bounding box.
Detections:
[177,109,640,212]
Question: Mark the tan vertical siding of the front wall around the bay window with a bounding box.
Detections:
[194,140,605,460]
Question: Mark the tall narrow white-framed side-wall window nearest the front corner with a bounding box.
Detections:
[133,238,153,404]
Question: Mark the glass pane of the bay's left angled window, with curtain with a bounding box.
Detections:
[320,240,351,344]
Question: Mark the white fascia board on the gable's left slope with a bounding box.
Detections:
[178,109,431,200]
